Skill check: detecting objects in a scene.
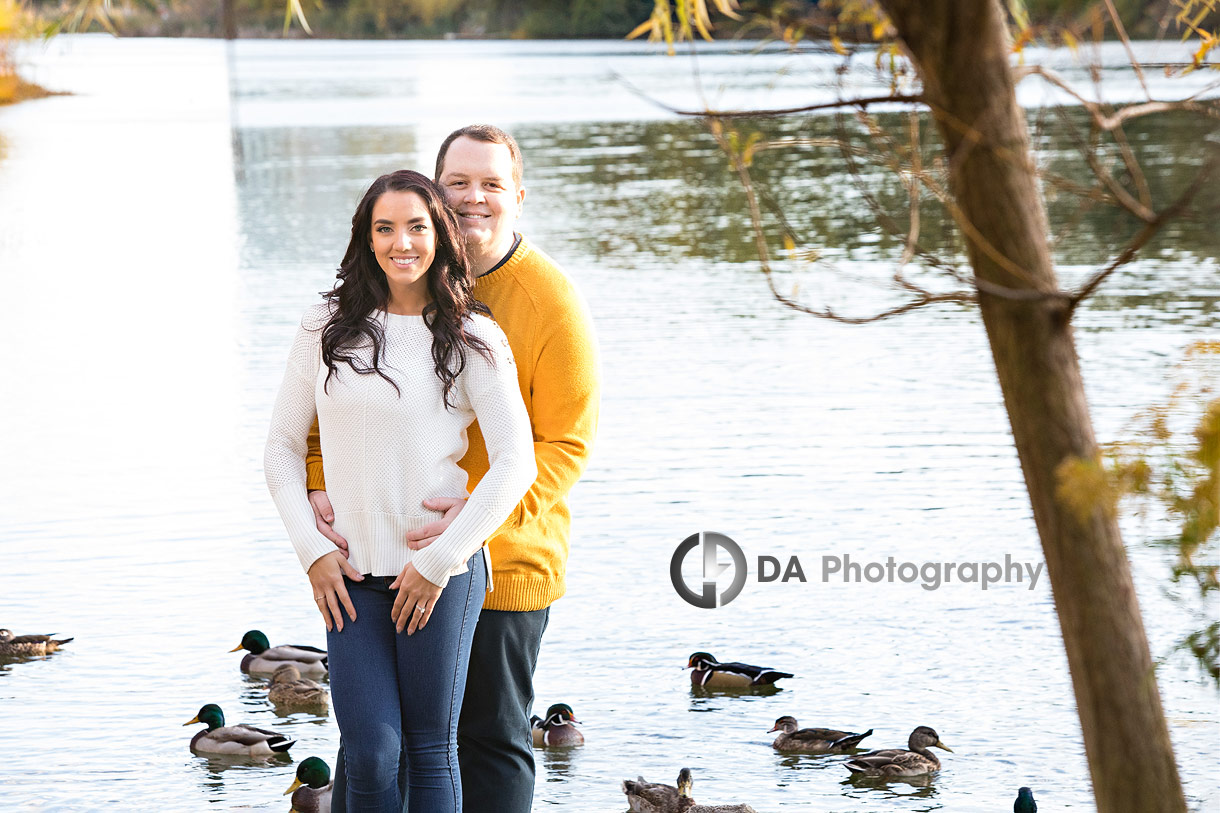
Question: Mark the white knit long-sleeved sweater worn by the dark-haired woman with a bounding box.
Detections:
[264,304,537,587]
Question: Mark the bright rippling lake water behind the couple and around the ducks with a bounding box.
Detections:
[0,35,1220,813]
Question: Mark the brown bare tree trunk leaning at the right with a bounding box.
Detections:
[881,0,1186,813]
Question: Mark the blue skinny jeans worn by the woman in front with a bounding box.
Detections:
[326,551,487,813]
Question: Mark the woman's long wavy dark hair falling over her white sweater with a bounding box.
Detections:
[322,170,493,408]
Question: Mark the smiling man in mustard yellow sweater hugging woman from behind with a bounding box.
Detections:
[307,125,598,813]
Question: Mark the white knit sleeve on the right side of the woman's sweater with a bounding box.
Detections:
[411,317,538,587]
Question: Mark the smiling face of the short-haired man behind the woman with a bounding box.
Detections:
[439,136,526,258]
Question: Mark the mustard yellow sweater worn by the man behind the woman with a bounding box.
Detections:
[307,238,599,612]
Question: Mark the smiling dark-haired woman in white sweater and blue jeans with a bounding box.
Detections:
[265,171,536,813]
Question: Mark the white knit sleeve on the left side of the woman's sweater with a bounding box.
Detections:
[262,306,337,571]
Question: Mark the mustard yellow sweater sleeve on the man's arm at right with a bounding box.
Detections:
[490,284,600,531]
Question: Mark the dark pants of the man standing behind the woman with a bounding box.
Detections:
[331,600,550,813]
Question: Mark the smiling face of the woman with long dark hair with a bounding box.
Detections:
[368,190,437,303]
